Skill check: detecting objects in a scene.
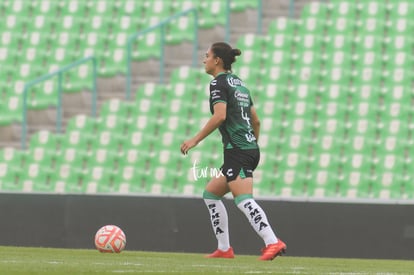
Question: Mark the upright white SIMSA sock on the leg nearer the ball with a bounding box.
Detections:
[204,199,230,251]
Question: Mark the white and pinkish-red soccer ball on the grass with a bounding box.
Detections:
[95,225,126,253]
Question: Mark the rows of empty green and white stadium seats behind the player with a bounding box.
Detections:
[0,0,414,203]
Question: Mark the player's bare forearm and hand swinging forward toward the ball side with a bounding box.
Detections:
[181,102,227,155]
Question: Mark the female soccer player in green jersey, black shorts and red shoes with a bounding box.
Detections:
[181,42,286,260]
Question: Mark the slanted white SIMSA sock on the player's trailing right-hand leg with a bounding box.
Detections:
[237,198,278,246]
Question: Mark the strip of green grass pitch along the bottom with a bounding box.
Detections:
[0,246,414,275]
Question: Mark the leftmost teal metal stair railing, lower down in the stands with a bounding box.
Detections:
[21,56,97,149]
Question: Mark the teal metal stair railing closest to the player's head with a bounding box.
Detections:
[126,8,198,100]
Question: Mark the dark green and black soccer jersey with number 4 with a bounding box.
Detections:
[210,73,258,149]
